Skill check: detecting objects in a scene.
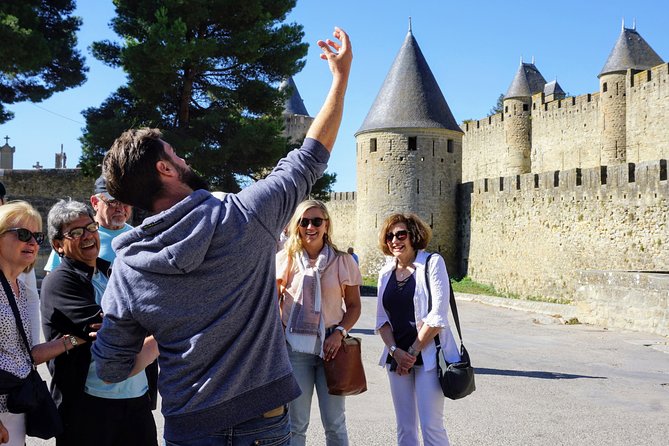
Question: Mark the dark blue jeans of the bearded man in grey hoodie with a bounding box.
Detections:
[165,412,291,446]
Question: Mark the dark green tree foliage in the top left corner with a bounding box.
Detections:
[0,0,87,124]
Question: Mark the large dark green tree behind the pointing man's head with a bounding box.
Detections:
[81,0,307,192]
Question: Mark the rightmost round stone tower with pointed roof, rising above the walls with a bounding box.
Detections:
[599,22,663,165]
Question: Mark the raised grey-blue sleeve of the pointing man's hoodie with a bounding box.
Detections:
[236,138,330,238]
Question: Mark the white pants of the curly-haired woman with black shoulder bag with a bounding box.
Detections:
[386,366,449,446]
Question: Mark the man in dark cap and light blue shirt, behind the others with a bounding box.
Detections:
[44,176,132,273]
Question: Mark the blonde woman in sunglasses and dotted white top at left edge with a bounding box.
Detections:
[0,201,85,446]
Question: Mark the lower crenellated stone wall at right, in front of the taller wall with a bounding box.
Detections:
[460,160,669,299]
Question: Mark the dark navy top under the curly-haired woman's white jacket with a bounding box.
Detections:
[383,271,423,365]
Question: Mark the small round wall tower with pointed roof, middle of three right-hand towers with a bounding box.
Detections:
[503,60,546,175]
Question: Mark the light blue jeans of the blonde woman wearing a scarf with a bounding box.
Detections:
[288,345,348,446]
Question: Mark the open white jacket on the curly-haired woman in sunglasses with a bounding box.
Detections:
[375,250,460,370]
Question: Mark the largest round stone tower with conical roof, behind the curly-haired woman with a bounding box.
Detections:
[355,29,463,275]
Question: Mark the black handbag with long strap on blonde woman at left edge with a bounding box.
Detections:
[0,271,63,440]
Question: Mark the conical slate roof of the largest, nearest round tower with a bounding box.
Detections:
[358,29,460,133]
